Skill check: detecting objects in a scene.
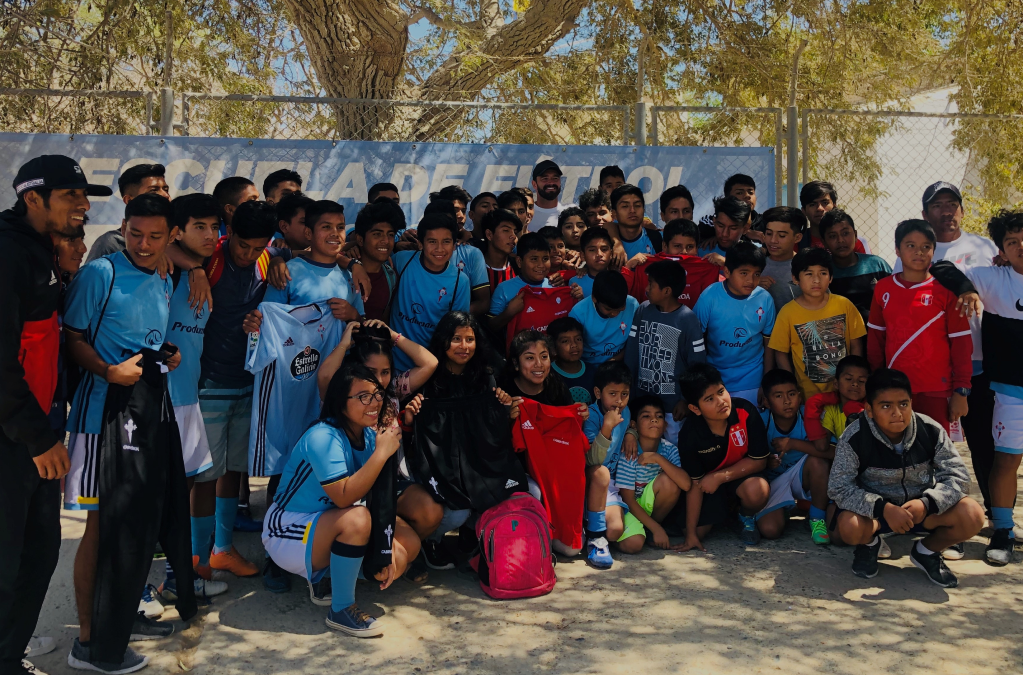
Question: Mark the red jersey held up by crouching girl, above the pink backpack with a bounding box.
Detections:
[512,399,589,548]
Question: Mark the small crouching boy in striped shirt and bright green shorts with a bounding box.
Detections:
[608,394,693,553]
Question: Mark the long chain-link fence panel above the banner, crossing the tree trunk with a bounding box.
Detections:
[182,93,631,145]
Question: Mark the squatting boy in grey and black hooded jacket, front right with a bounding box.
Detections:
[828,365,986,588]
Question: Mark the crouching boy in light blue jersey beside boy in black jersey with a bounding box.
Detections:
[757,368,835,545]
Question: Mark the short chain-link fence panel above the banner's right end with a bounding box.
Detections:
[650,105,785,204]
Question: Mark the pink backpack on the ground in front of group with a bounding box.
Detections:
[473,492,558,599]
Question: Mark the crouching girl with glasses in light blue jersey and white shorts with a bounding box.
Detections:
[263,363,403,637]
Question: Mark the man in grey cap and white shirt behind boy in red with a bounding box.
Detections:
[893,181,998,531]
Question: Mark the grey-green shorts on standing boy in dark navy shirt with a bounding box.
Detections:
[195,379,252,483]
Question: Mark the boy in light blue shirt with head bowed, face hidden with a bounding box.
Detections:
[569,270,639,366]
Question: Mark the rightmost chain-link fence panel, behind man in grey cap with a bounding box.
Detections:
[801,109,1023,261]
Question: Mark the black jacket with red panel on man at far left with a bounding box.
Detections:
[0,206,60,457]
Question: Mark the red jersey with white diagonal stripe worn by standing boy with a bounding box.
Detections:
[866,274,973,396]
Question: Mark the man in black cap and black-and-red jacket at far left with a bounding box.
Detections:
[0,154,113,675]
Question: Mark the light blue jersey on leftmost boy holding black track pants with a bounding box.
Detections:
[63,252,174,434]
